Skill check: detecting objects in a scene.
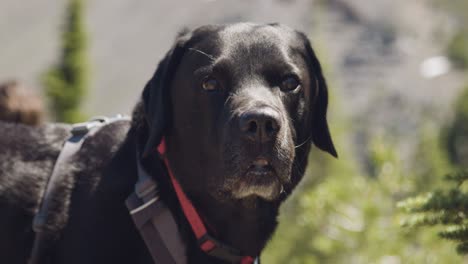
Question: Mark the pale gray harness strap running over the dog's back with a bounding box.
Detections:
[28,115,128,264]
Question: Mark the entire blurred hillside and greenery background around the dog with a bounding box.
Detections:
[0,0,468,264]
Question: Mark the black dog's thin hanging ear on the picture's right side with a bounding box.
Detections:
[300,33,338,158]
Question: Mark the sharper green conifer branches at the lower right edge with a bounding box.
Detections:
[399,84,468,254]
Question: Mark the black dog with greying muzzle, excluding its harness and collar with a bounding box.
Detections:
[0,24,336,264]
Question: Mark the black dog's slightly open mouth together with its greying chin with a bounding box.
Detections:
[233,157,283,201]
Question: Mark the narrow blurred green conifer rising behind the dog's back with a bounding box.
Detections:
[43,0,88,122]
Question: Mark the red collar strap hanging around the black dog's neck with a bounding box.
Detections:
[158,138,255,264]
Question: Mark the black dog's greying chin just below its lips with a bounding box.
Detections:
[232,169,283,201]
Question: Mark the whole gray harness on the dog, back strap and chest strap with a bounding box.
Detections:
[28,115,260,264]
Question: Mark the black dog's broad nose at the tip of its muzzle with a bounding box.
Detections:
[239,108,281,143]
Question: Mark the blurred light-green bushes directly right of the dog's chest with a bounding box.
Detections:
[262,91,463,264]
